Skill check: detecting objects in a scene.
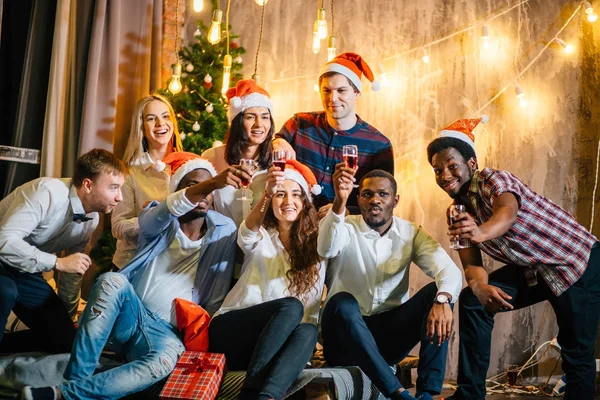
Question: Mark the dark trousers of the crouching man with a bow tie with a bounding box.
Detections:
[0,263,75,353]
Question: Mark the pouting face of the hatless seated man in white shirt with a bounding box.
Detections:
[358,177,399,233]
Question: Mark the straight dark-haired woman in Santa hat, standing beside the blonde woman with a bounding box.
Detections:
[202,79,274,226]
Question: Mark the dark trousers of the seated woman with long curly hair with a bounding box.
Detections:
[209,297,317,400]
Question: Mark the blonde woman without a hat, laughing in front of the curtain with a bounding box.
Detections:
[112,94,183,269]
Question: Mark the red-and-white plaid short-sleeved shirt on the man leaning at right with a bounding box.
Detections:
[460,168,598,296]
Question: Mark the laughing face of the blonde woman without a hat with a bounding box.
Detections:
[142,100,174,150]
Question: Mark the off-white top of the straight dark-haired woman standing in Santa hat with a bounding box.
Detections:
[202,145,267,226]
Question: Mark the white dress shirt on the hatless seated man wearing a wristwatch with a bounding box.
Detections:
[318,210,463,315]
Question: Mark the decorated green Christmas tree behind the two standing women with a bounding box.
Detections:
[160,9,246,154]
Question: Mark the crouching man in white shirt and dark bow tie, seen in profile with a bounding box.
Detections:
[0,149,127,353]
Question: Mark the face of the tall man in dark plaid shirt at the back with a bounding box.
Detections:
[319,74,360,120]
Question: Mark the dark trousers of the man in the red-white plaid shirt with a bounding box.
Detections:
[454,247,600,400]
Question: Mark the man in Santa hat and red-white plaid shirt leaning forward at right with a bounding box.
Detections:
[427,119,600,400]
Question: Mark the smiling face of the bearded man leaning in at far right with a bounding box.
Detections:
[431,147,477,199]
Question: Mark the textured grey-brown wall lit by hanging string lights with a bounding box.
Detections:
[221,0,600,379]
